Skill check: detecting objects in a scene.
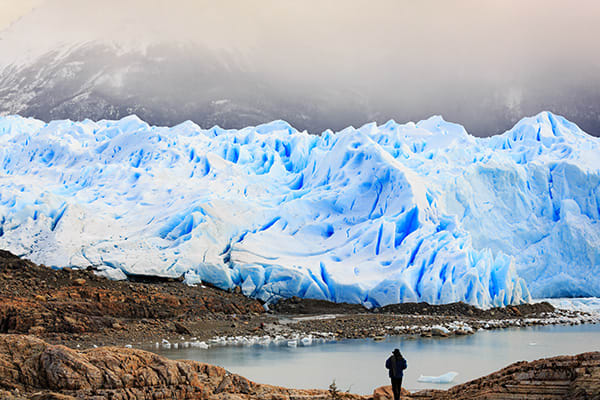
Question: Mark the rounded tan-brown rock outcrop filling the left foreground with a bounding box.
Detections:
[0,335,363,400]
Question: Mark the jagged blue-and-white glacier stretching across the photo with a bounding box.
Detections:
[0,112,600,307]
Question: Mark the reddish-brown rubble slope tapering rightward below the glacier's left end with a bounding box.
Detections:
[0,250,264,344]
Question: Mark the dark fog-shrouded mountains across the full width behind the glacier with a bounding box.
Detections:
[0,40,600,136]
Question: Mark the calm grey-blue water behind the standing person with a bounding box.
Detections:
[153,324,600,394]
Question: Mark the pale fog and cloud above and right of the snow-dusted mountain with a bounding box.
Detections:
[0,0,600,135]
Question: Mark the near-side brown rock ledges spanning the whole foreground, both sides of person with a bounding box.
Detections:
[0,334,600,400]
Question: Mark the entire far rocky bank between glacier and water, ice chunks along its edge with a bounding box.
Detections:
[0,251,600,349]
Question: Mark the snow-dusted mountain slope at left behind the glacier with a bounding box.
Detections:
[0,42,372,133]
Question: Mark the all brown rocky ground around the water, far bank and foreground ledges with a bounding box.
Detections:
[0,251,600,400]
